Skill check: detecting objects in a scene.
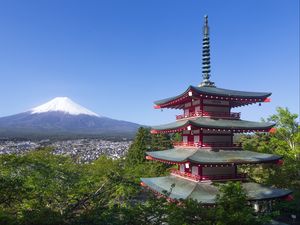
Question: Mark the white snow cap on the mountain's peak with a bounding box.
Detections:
[30,97,100,117]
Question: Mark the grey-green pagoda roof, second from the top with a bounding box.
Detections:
[152,117,275,132]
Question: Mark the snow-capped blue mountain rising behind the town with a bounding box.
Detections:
[0,97,140,138]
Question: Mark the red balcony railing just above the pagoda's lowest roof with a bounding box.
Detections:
[171,168,247,181]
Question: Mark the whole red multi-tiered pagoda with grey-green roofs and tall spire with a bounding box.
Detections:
[141,16,291,205]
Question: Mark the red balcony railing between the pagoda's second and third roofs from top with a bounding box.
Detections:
[173,142,241,148]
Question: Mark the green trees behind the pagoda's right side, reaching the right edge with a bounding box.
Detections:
[241,107,300,220]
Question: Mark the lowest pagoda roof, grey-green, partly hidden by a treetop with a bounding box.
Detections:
[141,175,292,204]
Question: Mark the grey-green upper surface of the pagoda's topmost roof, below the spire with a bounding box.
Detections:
[154,85,272,107]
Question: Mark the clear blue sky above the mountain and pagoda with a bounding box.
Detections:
[0,0,299,125]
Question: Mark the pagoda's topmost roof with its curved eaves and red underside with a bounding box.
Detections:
[154,86,272,108]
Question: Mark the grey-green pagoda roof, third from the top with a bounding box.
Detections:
[146,148,282,165]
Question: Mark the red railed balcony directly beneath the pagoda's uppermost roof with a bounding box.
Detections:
[176,111,241,120]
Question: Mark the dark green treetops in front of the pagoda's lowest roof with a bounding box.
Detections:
[131,183,269,225]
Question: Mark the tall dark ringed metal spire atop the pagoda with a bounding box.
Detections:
[199,15,215,87]
